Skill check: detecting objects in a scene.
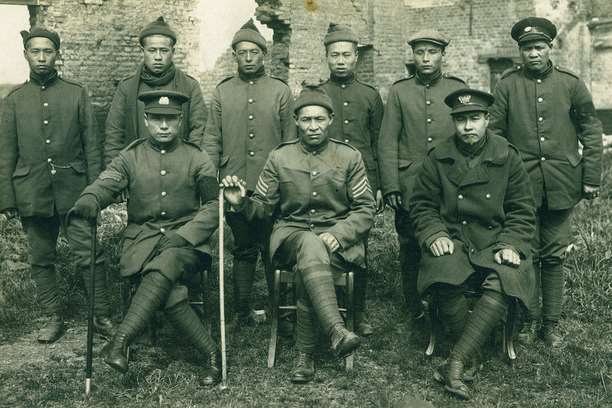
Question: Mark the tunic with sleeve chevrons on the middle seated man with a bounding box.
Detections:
[237,139,375,266]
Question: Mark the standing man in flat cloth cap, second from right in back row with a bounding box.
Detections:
[378,30,465,319]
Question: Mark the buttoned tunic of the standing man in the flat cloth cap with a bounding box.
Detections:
[378,74,465,209]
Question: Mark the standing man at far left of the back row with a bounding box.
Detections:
[0,26,113,343]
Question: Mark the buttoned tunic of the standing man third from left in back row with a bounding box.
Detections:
[202,75,295,191]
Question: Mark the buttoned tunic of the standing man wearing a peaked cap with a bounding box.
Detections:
[489,66,603,210]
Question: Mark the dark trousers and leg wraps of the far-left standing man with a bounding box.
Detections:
[21,213,110,316]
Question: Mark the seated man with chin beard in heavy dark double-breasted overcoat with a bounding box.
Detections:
[410,89,535,399]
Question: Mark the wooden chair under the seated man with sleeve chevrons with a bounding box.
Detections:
[268,269,355,371]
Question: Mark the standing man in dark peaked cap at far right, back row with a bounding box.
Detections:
[490,17,603,347]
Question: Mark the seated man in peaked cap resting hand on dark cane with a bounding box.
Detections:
[73,90,220,385]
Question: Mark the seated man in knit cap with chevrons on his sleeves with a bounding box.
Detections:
[222,88,375,383]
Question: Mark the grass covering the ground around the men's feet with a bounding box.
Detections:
[0,154,612,408]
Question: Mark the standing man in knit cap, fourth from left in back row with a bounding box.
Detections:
[321,23,384,336]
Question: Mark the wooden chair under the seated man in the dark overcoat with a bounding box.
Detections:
[425,290,518,364]
